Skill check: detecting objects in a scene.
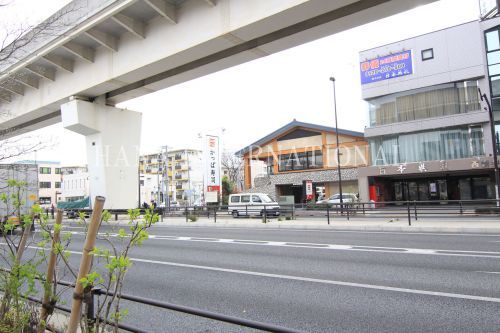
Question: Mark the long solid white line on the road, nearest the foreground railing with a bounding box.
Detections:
[14,243,500,303]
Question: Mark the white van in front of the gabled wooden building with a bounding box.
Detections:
[227,193,280,217]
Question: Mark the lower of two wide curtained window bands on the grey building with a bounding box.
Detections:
[369,125,484,165]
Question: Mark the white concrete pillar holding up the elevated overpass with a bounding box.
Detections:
[61,100,142,209]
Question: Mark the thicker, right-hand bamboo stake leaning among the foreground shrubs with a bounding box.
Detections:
[66,197,106,333]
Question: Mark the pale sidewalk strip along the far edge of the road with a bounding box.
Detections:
[149,216,500,235]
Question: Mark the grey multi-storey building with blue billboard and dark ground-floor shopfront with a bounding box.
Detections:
[359,16,500,201]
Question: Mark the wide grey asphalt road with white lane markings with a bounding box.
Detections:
[7,226,500,332]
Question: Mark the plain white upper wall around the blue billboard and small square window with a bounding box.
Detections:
[360,21,487,99]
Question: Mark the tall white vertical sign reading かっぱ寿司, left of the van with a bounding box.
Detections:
[205,135,220,202]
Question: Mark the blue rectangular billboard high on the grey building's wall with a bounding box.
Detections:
[360,50,413,84]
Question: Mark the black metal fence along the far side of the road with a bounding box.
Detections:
[67,199,500,225]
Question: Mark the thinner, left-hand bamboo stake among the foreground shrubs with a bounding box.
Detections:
[38,209,63,333]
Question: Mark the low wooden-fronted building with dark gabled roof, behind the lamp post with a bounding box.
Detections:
[236,120,368,203]
